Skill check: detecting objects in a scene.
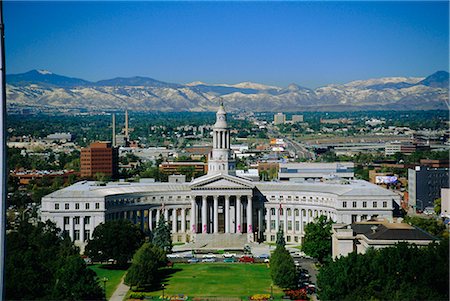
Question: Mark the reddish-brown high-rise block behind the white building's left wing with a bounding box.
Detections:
[80,142,119,178]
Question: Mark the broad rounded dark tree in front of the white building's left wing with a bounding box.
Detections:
[86,219,144,266]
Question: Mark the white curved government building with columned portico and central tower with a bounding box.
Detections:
[41,106,400,246]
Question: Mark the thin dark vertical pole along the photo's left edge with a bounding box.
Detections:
[0,0,8,300]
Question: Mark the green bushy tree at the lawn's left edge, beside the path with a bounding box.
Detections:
[125,243,167,288]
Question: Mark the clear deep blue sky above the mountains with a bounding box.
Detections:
[4,1,449,88]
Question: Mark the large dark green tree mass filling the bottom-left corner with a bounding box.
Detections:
[5,221,103,300]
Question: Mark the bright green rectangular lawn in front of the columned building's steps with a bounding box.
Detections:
[139,263,282,298]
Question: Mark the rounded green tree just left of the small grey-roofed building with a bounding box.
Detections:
[302,215,333,263]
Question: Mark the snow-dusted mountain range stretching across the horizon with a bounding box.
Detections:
[6,70,449,112]
